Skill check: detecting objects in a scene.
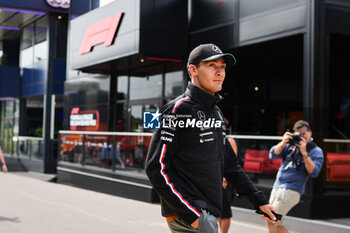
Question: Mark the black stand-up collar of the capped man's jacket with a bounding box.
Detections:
[185,82,224,109]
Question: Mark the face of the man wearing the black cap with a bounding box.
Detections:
[189,57,226,95]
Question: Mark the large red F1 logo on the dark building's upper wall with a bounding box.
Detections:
[79,12,124,55]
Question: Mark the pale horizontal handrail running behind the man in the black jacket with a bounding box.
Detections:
[59,130,282,140]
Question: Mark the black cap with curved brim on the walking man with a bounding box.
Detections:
[187,44,236,66]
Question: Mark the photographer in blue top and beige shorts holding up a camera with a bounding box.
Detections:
[267,120,323,233]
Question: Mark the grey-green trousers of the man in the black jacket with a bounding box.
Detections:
[168,210,218,233]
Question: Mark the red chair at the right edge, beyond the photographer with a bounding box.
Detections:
[326,153,350,181]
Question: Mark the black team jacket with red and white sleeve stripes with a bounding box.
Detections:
[146,83,268,224]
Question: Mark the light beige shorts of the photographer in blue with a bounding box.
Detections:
[270,188,300,226]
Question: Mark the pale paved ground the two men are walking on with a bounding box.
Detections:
[0,172,350,233]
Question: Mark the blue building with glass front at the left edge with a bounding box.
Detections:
[0,0,73,172]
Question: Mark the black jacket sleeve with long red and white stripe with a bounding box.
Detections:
[146,105,200,224]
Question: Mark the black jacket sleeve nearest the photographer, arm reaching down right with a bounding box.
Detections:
[224,138,269,208]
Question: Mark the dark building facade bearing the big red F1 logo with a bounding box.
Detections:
[58,0,350,218]
